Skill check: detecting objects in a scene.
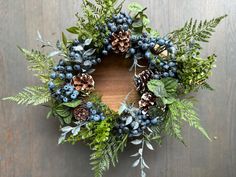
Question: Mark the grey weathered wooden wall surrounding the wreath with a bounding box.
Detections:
[0,0,236,177]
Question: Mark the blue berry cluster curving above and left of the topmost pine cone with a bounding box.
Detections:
[102,12,133,55]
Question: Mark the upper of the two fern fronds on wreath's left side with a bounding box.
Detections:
[19,47,54,83]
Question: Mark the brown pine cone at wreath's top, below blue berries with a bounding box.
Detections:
[111,31,131,53]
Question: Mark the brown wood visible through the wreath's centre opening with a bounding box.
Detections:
[93,55,147,111]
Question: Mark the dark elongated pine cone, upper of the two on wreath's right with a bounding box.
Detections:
[134,69,153,94]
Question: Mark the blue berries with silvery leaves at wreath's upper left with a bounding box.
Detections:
[69,39,101,73]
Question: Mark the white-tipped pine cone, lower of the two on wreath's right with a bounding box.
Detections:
[139,92,156,111]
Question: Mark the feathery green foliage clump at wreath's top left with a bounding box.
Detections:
[67,0,123,48]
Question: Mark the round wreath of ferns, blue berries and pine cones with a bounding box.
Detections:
[4,0,226,177]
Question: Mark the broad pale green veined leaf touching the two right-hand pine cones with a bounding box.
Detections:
[147,80,167,98]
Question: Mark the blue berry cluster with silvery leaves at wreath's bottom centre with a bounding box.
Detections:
[116,108,163,137]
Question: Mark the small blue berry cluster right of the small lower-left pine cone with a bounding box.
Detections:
[86,102,105,122]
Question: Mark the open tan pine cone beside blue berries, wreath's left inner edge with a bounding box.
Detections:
[72,74,95,93]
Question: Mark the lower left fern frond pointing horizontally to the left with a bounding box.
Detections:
[3,86,51,106]
